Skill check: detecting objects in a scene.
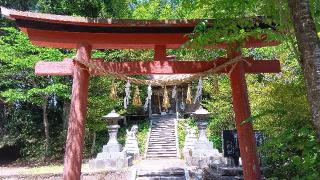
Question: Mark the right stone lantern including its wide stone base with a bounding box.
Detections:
[187,106,225,167]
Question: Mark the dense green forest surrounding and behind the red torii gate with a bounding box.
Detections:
[0,0,320,179]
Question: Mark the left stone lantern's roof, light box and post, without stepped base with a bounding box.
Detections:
[103,110,122,152]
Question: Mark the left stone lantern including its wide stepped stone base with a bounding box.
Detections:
[89,110,131,169]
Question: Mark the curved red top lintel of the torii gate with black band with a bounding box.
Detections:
[1,7,276,49]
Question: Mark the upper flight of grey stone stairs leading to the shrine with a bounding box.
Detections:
[146,115,178,159]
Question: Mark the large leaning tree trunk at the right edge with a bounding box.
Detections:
[288,0,320,142]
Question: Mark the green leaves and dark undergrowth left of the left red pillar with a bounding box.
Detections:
[0,27,70,159]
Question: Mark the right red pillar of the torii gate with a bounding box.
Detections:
[228,50,261,180]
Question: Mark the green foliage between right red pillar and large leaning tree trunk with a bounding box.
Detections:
[247,45,320,179]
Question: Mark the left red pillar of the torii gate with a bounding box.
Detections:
[63,44,91,180]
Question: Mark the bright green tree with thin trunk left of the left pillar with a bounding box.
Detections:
[0,28,69,157]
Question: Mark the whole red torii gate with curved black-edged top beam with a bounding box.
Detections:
[1,7,280,179]
